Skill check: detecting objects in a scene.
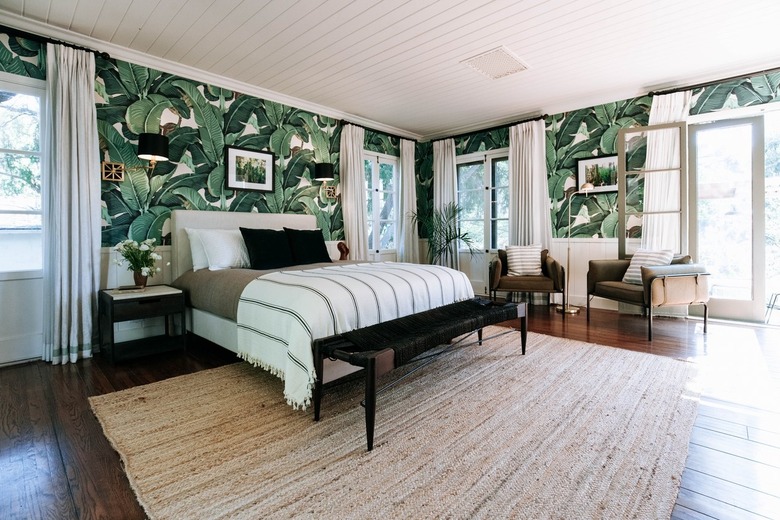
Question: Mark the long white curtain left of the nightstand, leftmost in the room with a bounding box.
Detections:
[42,44,100,364]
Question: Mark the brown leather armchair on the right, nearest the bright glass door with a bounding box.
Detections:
[587,256,709,341]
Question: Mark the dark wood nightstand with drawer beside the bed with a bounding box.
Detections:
[98,285,187,363]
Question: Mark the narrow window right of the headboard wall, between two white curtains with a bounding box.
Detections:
[363,151,398,253]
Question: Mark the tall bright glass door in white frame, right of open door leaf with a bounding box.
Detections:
[689,116,766,321]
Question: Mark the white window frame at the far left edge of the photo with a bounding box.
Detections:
[0,71,49,281]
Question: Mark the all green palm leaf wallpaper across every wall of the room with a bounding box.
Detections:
[0,29,780,246]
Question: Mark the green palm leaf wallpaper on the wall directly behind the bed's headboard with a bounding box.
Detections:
[96,53,346,246]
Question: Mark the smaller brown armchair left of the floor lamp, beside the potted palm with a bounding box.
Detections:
[489,249,566,306]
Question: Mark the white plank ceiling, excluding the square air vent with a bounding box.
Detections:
[0,0,780,139]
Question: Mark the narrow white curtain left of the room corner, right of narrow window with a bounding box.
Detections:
[398,139,420,264]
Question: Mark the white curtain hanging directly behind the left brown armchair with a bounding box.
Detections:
[509,119,552,249]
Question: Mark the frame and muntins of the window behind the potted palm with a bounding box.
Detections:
[455,148,509,253]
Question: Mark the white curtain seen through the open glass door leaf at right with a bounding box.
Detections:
[641,90,691,253]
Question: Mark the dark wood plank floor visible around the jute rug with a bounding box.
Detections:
[0,307,780,519]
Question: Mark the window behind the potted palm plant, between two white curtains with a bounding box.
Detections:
[457,150,509,251]
